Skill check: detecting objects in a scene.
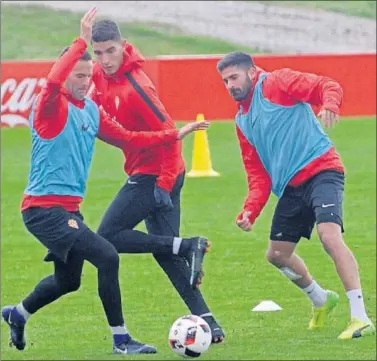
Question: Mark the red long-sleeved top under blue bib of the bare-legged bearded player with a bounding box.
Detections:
[236,68,344,223]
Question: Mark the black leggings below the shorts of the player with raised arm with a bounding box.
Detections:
[23,229,124,326]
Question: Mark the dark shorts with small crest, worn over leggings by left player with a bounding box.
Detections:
[22,207,88,262]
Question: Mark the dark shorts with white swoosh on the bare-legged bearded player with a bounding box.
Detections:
[270,171,344,243]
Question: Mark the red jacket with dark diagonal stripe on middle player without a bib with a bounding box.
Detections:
[91,43,185,191]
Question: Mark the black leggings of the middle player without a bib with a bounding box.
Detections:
[98,174,210,316]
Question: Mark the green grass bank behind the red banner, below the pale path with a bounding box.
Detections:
[1,4,256,60]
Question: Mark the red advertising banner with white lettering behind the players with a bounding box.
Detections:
[1,54,376,127]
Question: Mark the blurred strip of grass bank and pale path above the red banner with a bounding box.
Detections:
[1,1,376,59]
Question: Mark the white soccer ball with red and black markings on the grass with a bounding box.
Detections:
[169,315,212,357]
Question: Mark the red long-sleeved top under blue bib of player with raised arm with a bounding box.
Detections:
[21,38,178,212]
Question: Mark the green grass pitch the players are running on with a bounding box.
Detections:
[1,119,376,360]
